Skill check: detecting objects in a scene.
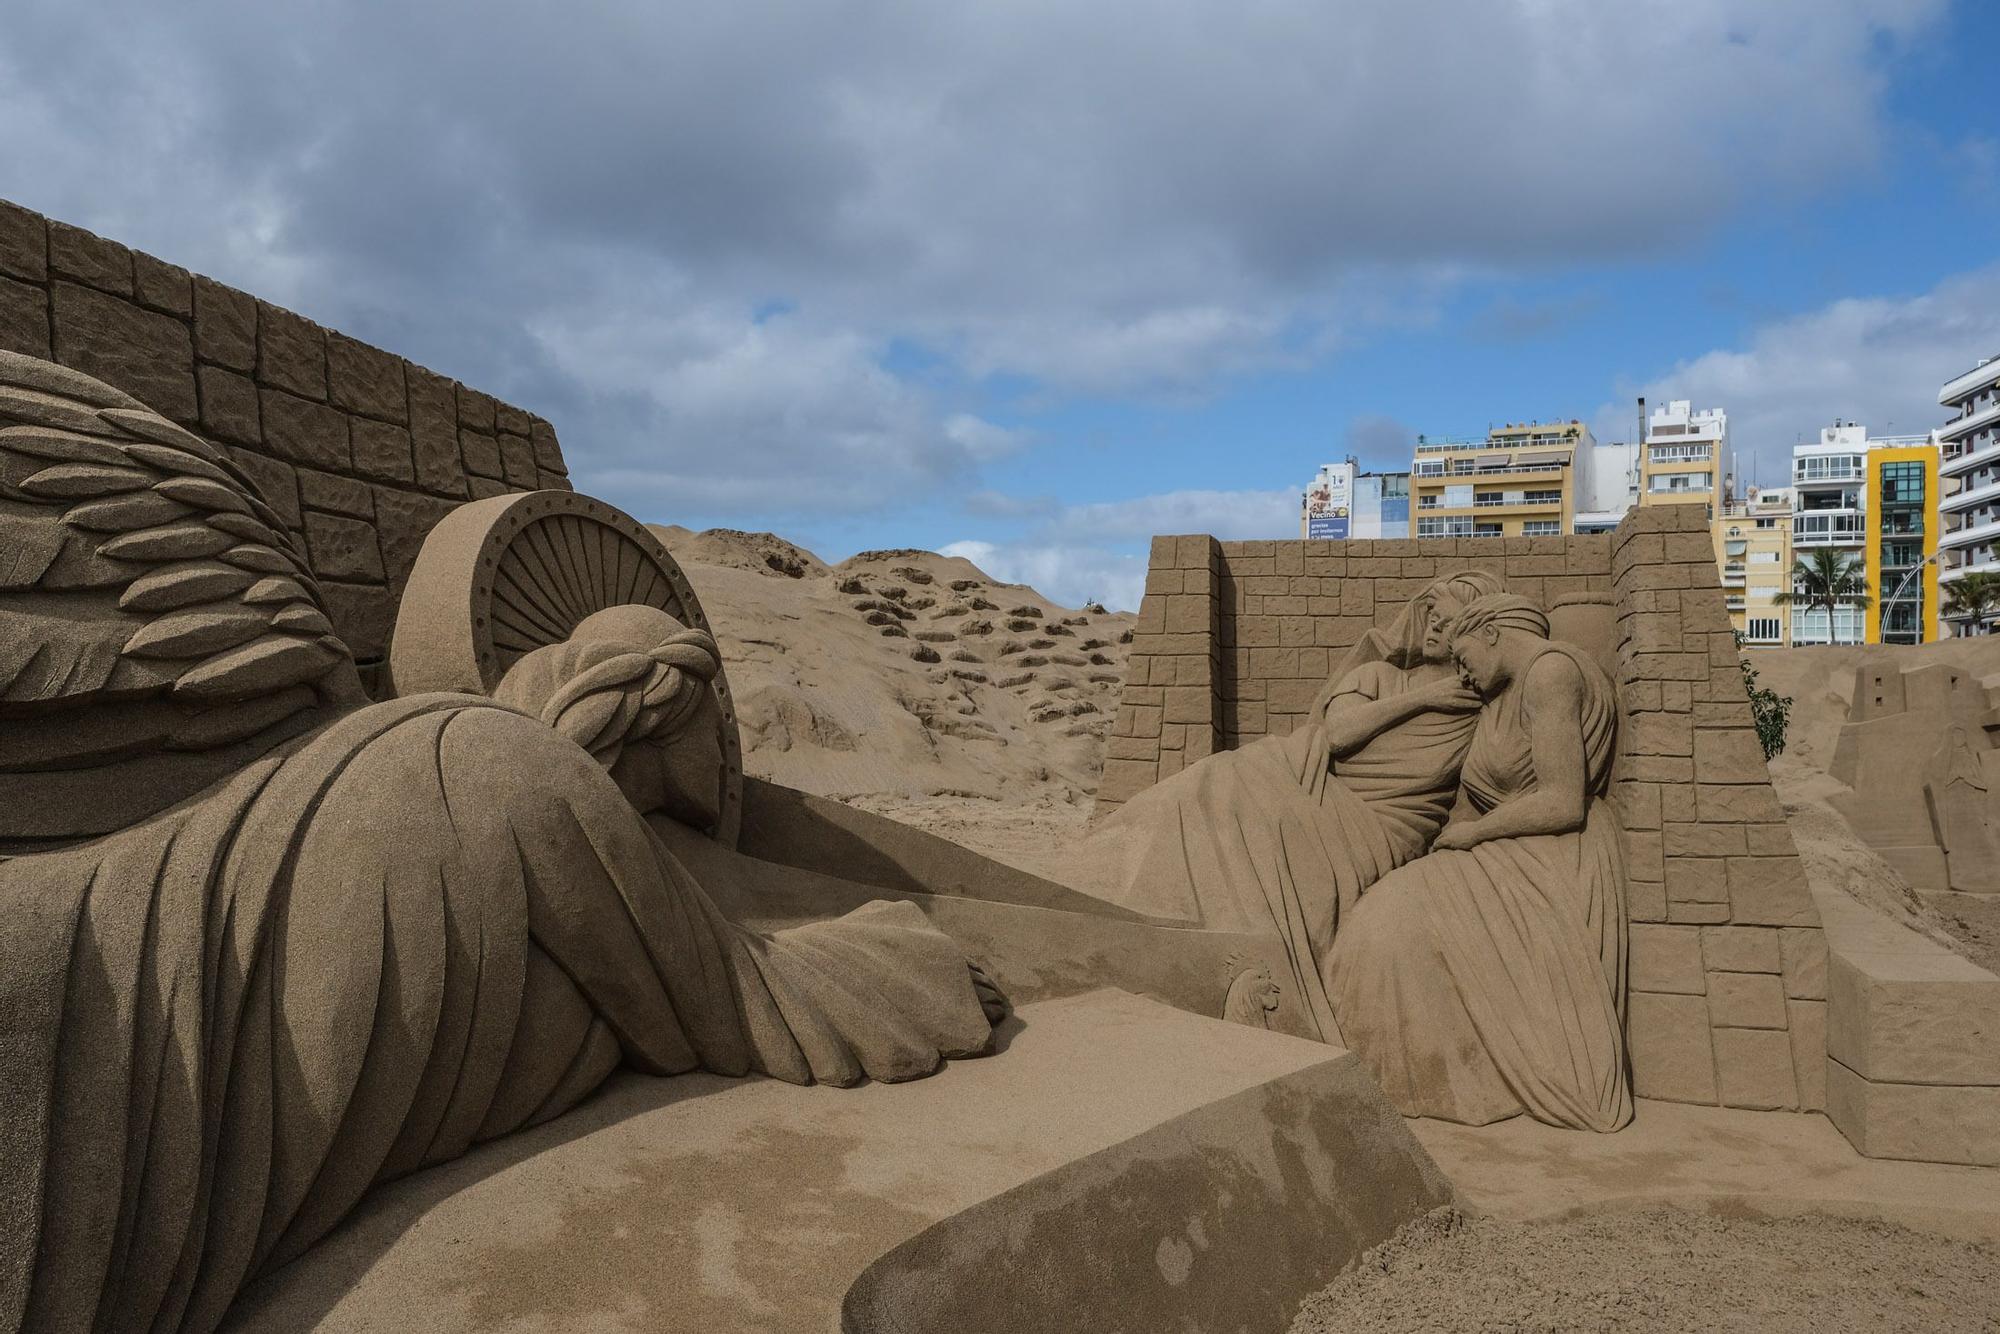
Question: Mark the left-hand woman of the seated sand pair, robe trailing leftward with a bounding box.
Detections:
[1078,570,1500,1042]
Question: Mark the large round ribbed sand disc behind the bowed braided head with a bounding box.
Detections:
[390,490,744,848]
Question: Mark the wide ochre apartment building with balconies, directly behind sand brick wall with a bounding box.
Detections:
[1410,418,1596,538]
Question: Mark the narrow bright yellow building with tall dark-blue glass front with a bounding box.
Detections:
[1862,436,1942,644]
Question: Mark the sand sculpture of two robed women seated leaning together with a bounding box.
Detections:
[1082,570,1632,1130]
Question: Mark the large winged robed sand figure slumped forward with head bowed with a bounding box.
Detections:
[0,354,1002,1330]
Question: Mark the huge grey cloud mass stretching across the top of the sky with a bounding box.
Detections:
[0,0,1944,514]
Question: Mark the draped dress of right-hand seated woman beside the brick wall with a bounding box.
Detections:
[1326,644,1632,1130]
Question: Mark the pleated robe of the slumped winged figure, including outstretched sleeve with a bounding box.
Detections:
[0,696,990,1330]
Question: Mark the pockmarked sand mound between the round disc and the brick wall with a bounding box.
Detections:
[654,528,1134,808]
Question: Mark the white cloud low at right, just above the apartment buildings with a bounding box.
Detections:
[1594,264,2000,482]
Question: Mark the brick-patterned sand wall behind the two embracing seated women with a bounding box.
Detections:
[1098,506,1826,1110]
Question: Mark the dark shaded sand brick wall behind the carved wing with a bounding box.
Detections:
[0,200,570,688]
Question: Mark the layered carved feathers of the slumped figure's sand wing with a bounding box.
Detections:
[0,352,350,716]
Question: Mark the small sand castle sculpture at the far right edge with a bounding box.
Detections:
[1830,658,2000,894]
